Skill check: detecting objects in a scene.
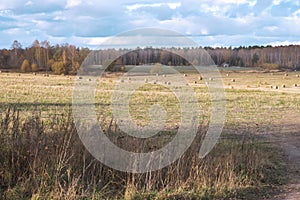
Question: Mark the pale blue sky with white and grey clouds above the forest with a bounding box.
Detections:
[0,0,300,49]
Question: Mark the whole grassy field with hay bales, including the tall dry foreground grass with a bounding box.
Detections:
[0,68,300,199]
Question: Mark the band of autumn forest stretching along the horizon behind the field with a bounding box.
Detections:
[0,40,300,74]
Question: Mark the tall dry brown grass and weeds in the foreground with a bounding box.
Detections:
[0,108,282,199]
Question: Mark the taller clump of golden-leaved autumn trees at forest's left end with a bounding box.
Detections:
[0,40,90,74]
